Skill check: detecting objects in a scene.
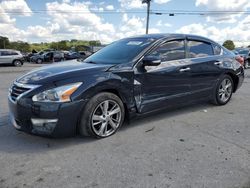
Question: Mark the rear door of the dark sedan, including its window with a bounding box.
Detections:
[186,38,222,98]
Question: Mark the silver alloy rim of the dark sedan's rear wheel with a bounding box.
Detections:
[218,78,233,103]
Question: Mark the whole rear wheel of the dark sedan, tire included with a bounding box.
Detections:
[212,75,234,105]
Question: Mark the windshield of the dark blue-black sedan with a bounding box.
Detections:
[84,38,155,64]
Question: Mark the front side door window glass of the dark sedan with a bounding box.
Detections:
[150,40,185,61]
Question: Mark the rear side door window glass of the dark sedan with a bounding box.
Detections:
[188,40,214,58]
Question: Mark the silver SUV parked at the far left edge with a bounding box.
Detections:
[0,49,24,67]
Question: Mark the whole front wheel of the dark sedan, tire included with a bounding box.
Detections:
[79,92,125,138]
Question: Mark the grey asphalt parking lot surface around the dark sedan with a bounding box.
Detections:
[0,64,250,188]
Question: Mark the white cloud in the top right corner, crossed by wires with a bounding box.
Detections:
[195,0,250,23]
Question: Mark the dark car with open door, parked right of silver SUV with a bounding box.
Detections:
[30,51,64,64]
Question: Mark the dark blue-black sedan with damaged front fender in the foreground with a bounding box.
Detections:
[9,34,244,138]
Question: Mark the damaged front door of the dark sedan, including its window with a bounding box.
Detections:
[134,40,190,113]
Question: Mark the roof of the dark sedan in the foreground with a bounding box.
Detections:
[128,33,216,43]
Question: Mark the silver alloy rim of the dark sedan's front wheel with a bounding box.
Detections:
[91,100,122,137]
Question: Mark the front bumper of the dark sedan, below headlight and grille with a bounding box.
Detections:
[8,97,86,137]
